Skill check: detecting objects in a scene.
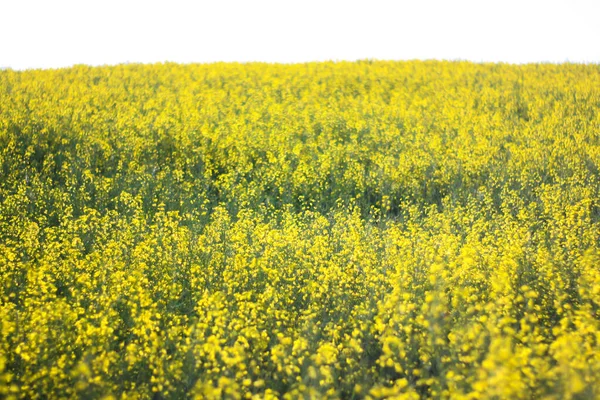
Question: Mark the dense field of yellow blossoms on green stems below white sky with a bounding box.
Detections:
[0,61,600,399]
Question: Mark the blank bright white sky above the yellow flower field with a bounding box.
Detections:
[0,0,600,69]
